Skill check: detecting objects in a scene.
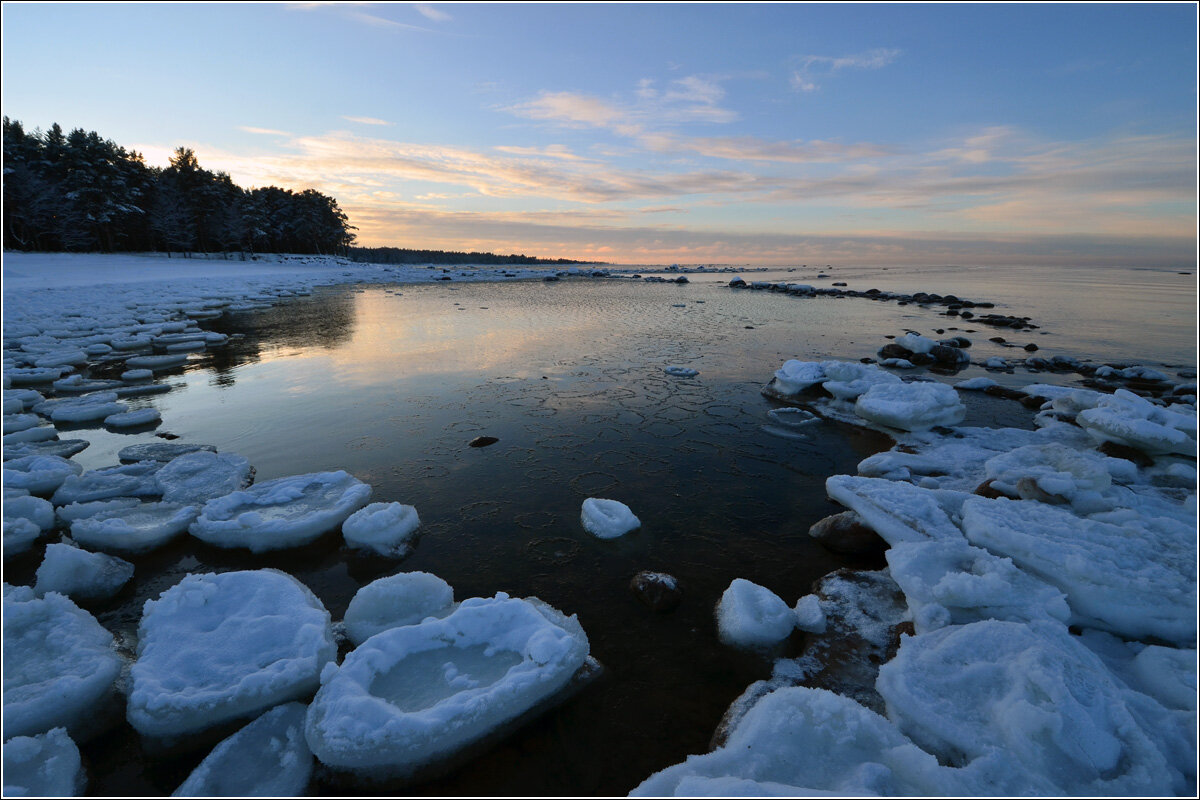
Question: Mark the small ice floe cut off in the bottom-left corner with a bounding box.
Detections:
[4,728,88,798]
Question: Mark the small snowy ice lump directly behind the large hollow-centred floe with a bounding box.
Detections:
[343,572,454,645]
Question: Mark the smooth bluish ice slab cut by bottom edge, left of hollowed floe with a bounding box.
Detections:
[172,703,312,798]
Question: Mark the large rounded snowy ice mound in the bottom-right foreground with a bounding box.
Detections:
[877,620,1186,795]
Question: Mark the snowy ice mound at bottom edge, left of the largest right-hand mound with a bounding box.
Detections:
[630,686,955,798]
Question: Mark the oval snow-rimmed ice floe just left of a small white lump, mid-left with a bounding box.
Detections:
[190,471,371,553]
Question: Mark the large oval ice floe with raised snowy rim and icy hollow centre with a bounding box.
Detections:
[305,594,588,777]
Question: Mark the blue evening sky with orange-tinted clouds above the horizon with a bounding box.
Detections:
[0,2,1196,266]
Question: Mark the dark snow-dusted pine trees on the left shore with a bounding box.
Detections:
[4,116,354,254]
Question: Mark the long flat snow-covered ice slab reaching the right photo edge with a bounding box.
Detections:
[962,498,1196,646]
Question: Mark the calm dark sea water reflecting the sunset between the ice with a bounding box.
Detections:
[23,261,1195,795]
